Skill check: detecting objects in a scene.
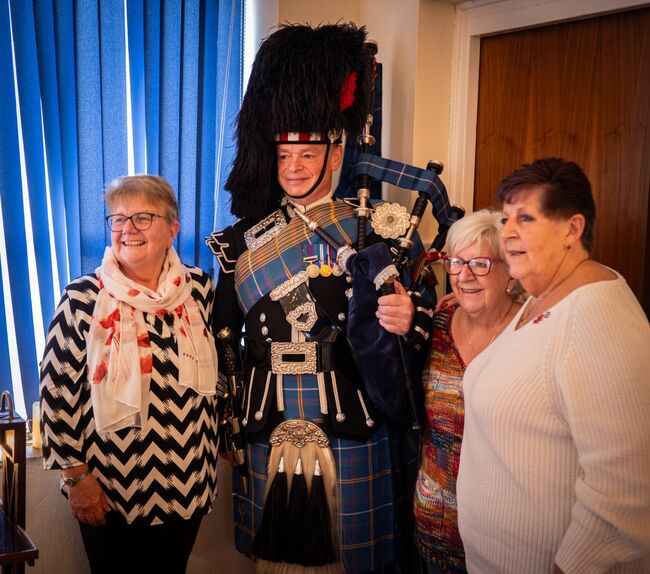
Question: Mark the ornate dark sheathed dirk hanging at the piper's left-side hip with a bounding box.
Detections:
[215,327,248,494]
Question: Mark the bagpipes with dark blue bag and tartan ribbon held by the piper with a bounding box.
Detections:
[294,155,464,430]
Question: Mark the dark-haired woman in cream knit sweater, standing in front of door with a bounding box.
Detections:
[458,158,650,574]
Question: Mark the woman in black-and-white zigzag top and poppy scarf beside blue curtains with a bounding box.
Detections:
[41,175,217,574]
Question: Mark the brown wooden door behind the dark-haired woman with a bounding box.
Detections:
[474,8,650,315]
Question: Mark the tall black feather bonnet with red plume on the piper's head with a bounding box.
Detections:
[225,24,373,221]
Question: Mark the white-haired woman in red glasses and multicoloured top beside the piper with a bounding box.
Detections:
[414,210,520,574]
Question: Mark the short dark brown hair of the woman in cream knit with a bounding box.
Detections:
[496,157,596,251]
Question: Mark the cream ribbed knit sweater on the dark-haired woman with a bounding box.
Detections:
[458,275,650,574]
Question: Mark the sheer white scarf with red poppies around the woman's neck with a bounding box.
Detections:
[87,247,217,432]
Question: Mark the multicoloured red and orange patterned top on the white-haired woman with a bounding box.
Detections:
[414,306,466,573]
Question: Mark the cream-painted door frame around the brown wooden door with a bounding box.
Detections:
[449,0,650,210]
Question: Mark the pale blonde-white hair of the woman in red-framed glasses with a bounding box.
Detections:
[446,209,505,260]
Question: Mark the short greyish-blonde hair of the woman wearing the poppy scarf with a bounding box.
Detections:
[104,175,178,222]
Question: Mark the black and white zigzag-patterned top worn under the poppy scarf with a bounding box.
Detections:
[41,267,218,524]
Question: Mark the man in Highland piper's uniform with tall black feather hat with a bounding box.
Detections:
[207,25,429,573]
